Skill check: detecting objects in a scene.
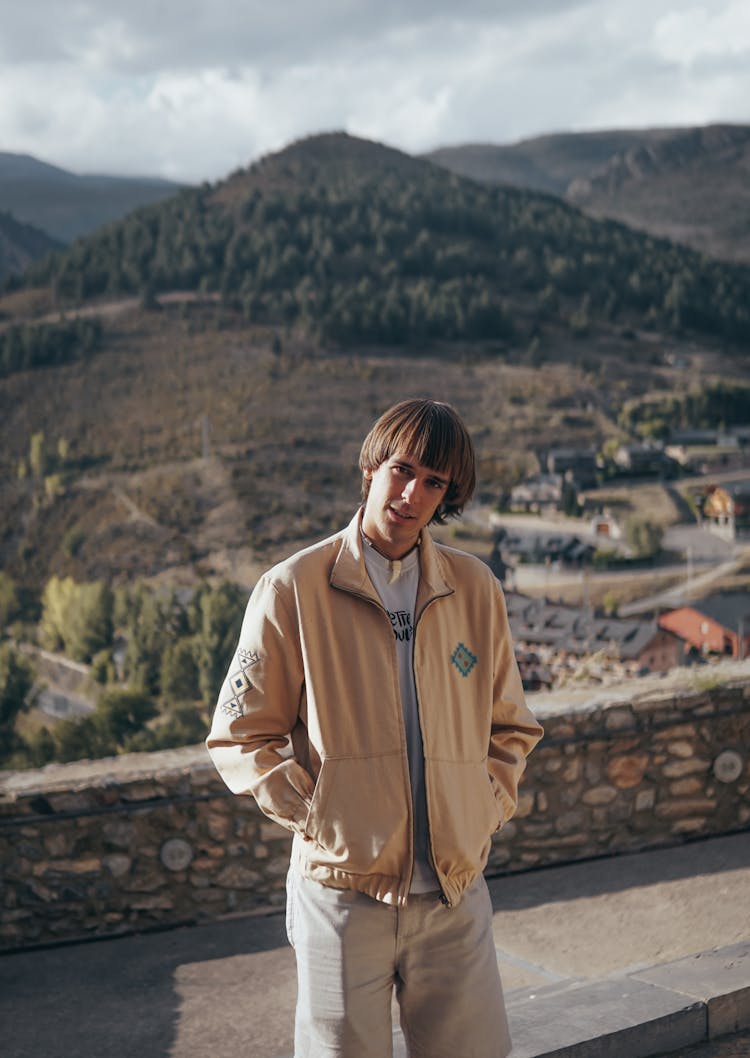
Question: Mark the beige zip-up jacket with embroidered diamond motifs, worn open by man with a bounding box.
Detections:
[206,512,543,905]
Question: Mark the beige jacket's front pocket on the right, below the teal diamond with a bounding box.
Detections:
[425,760,502,876]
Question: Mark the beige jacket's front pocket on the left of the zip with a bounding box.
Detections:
[305,753,410,875]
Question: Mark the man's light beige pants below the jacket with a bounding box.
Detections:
[287,871,511,1058]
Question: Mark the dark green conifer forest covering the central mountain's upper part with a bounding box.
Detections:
[20,134,750,344]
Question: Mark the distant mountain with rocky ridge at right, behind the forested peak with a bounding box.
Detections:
[425,125,750,262]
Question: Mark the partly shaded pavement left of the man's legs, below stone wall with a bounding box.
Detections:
[0,914,294,1058]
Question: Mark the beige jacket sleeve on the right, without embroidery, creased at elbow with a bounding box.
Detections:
[487,581,544,825]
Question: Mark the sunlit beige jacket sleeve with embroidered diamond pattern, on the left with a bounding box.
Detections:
[206,573,314,835]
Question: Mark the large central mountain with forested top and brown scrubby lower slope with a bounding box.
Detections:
[0,133,750,591]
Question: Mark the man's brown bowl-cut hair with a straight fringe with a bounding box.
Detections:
[360,399,476,525]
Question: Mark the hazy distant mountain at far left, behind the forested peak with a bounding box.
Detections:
[0,151,184,242]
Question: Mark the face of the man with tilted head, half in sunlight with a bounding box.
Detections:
[362,452,451,560]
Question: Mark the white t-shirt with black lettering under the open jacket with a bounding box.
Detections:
[363,534,440,893]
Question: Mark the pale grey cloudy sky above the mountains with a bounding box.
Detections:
[0,0,750,182]
